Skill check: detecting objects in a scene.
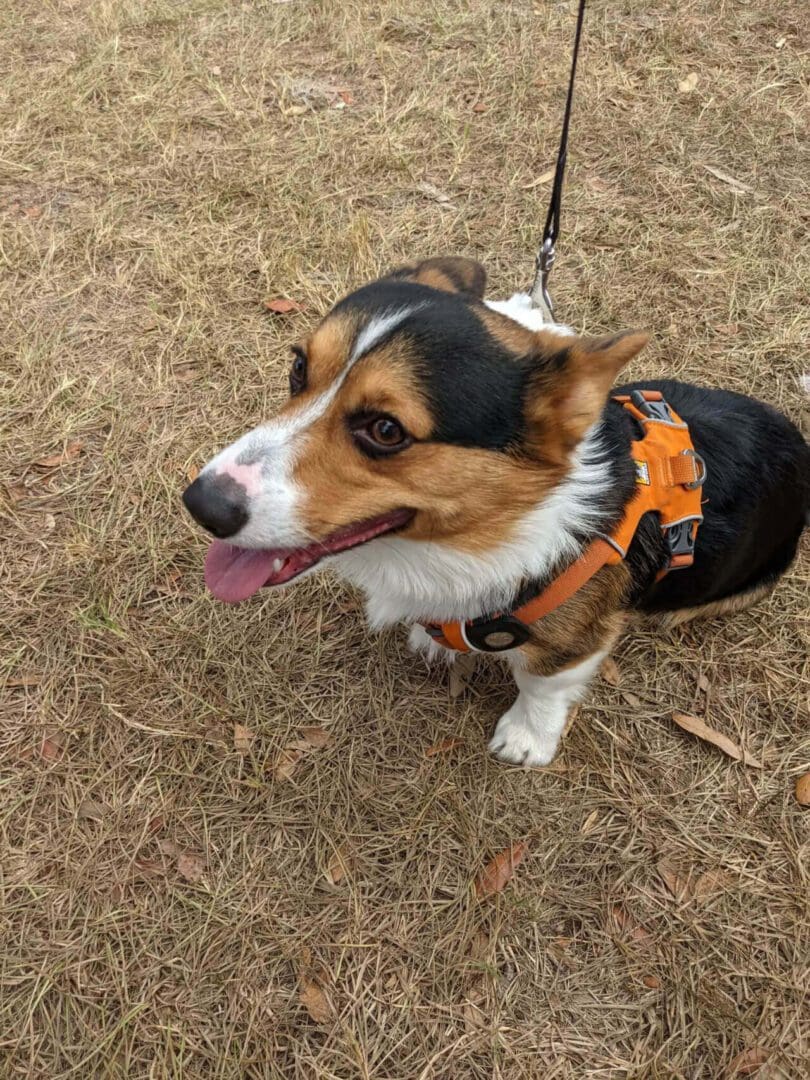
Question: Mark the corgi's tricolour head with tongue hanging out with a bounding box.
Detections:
[184,258,646,602]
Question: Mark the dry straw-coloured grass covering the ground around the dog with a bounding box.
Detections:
[0,0,810,1080]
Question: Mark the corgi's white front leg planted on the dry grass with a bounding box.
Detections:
[489,650,607,765]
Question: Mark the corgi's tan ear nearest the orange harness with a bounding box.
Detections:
[527,330,649,459]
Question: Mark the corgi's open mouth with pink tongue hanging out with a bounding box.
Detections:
[205,509,415,604]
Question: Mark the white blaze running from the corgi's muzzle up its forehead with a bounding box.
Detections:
[202,305,422,549]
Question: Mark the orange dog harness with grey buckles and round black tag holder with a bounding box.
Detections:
[424,390,706,652]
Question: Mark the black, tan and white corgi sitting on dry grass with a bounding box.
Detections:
[184,258,810,766]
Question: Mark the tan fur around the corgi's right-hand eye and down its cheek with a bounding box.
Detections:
[294,341,564,552]
